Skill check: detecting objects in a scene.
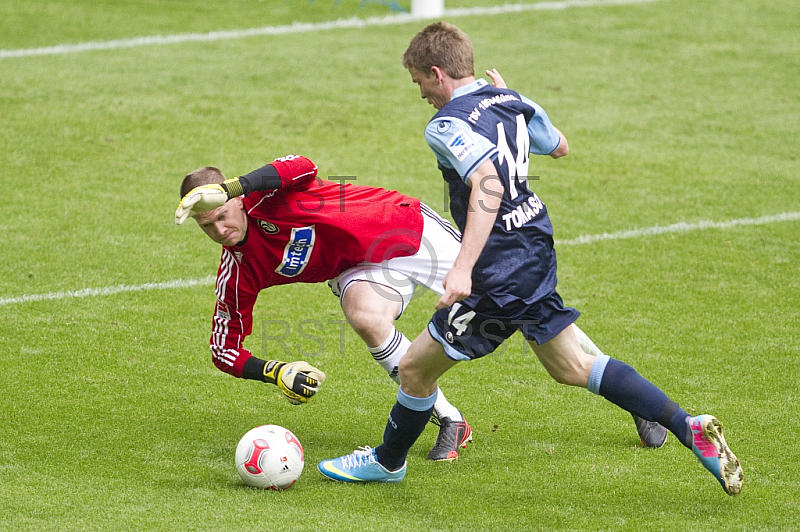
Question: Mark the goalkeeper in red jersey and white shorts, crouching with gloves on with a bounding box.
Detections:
[175,155,472,460]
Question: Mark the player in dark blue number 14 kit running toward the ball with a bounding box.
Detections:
[318,22,743,495]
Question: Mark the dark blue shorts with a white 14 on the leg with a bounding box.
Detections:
[428,291,581,360]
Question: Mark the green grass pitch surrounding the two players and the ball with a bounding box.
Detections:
[0,0,800,531]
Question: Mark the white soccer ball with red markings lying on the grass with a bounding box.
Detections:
[236,425,305,490]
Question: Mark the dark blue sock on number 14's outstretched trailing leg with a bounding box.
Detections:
[588,355,692,449]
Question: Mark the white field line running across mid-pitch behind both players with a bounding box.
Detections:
[0,212,800,307]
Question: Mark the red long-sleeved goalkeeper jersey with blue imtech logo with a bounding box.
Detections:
[211,156,423,377]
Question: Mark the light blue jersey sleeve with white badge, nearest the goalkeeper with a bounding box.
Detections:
[425,117,496,181]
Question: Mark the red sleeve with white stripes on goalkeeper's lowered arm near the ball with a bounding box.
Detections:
[210,248,258,377]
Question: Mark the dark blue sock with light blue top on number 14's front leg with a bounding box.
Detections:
[375,388,439,471]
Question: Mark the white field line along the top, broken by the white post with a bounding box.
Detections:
[0,0,657,59]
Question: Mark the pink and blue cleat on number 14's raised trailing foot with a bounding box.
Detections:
[688,414,744,497]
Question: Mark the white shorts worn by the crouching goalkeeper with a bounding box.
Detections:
[328,204,461,317]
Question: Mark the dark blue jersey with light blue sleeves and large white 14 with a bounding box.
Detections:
[425,79,560,306]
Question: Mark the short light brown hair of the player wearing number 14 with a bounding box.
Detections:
[403,21,475,79]
